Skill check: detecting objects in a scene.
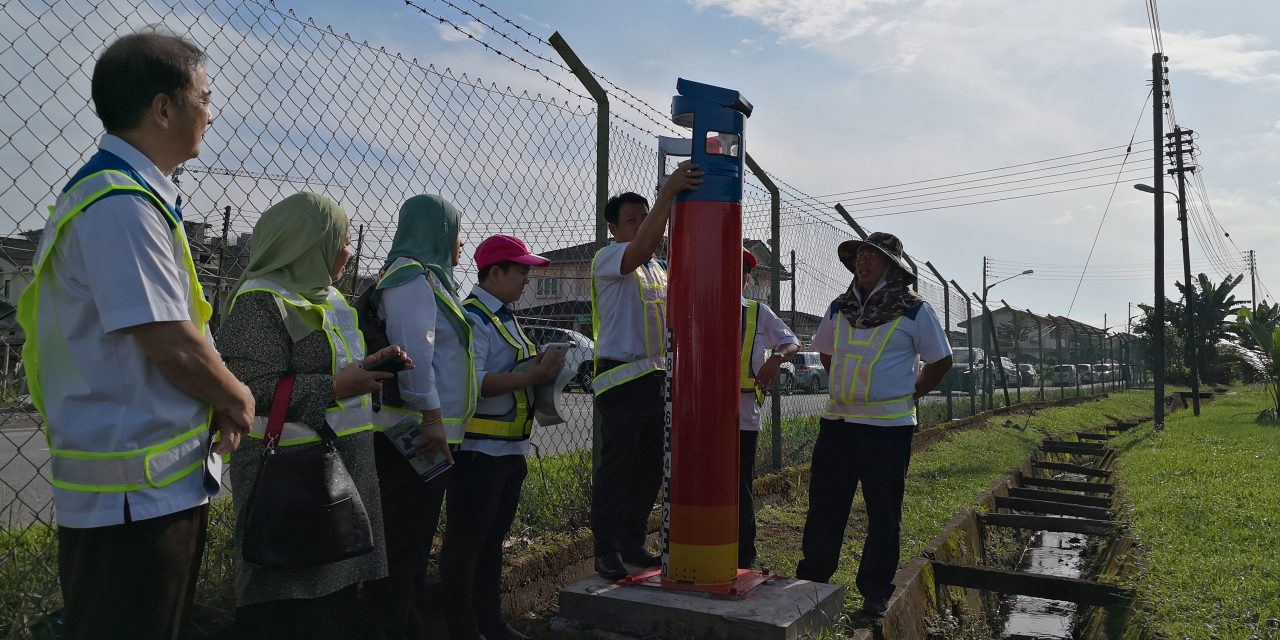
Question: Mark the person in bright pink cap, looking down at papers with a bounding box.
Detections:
[440,236,564,640]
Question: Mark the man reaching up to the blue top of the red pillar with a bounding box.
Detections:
[591,164,703,580]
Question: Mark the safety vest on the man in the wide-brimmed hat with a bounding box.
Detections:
[824,316,915,420]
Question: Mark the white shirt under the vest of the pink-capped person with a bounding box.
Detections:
[462,284,532,456]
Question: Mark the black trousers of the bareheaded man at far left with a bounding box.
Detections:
[58,503,209,640]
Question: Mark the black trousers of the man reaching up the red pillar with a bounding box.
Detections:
[591,368,667,556]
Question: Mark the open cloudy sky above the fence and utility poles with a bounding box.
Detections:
[270,0,1280,326]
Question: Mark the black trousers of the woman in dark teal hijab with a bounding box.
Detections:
[356,434,456,640]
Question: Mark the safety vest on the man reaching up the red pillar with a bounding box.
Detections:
[591,250,667,396]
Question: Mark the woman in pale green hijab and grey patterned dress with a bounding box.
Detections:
[218,193,407,640]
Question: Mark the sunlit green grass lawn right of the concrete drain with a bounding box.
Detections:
[1112,388,1280,639]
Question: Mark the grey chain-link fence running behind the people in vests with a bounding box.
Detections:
[0,0,1137,637]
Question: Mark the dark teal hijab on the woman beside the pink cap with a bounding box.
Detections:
[378,196,462,296]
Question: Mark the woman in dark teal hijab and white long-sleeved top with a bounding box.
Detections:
[361,196,479,640]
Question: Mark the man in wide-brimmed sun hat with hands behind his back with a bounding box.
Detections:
[796,233,951,620]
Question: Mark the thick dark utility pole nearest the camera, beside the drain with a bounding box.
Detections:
[1151,51,1169,430]
